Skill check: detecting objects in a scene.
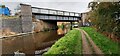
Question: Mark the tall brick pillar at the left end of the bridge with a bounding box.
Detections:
[21,4,32,33]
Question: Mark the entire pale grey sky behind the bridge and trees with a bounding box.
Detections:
[0,0,92,13]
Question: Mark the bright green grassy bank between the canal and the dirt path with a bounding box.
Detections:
[44,29,82,56]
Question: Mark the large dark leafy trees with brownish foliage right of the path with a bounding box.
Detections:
[88,2,120,38]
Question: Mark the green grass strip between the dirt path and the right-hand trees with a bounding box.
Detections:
[81,27,119,54]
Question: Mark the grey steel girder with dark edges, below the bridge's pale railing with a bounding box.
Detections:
[33,13,81,22]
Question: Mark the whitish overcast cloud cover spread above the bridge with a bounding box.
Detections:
[2,0,89,13]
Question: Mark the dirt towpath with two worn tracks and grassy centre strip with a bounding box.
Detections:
[78,29,104,56]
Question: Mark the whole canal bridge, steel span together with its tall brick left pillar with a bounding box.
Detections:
[20,4,81,32]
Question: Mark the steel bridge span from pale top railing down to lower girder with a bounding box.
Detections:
[31,7,81,22]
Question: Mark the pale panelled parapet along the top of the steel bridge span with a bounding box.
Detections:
[32,7,81,17]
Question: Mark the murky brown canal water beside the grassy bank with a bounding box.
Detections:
[0,30,62,56]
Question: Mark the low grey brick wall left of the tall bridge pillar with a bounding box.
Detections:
[0,18,22,33]
